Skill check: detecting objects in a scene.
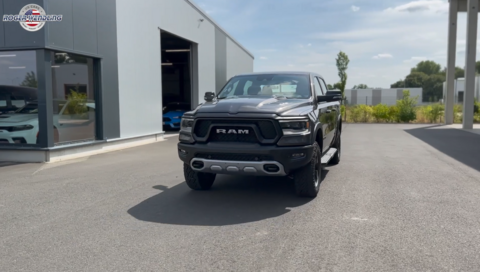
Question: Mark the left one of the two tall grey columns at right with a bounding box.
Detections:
[444,0,458,125]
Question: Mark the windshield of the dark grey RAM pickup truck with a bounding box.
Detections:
[218,74,312,99]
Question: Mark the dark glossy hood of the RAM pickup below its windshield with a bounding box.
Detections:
[194,98,312,115]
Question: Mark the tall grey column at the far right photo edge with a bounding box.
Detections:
[463,0,478,129]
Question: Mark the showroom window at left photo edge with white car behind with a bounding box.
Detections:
[0,51,39,145]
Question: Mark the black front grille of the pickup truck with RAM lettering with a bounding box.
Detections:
[194,119,278,143]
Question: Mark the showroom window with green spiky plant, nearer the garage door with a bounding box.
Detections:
[52,52,96,145]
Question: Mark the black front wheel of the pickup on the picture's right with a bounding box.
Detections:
[294,142,322,197]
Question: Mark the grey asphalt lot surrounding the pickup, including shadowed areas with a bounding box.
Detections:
[0,125,480,272]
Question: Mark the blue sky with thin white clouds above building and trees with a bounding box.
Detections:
[193,0,480,88]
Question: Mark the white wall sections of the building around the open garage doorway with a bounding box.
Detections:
[116,0,253,138]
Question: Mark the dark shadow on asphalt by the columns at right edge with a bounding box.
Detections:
[405,126,480,171]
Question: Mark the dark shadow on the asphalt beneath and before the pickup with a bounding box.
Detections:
[128,170,328,226]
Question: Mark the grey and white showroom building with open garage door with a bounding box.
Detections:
[0,0,254,161]
